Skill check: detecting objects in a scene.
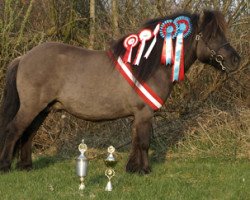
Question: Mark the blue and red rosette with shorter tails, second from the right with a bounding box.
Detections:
[160,20,178,65]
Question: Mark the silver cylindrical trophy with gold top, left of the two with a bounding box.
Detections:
[76,140,88,190]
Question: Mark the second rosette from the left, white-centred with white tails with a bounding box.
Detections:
[133,29,153,65]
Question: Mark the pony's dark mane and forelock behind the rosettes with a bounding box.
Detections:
[111,10,226,81]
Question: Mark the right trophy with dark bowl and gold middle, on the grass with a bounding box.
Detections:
[104,146,117,192]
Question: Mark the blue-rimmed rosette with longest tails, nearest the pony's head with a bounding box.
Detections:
[172,16,191,82]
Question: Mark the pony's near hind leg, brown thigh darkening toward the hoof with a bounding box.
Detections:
[0,104,46,171]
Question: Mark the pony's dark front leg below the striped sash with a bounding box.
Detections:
[126,108,153,174]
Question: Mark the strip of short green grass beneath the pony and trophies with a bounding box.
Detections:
[0,155,250,200]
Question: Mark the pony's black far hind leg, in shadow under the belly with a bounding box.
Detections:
[16,108,49,170]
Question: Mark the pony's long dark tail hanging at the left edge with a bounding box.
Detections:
[0,57,20,151]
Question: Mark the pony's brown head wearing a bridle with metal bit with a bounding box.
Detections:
[195,11,240,72]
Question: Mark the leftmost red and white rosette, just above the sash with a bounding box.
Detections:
[123,34,139,63]
